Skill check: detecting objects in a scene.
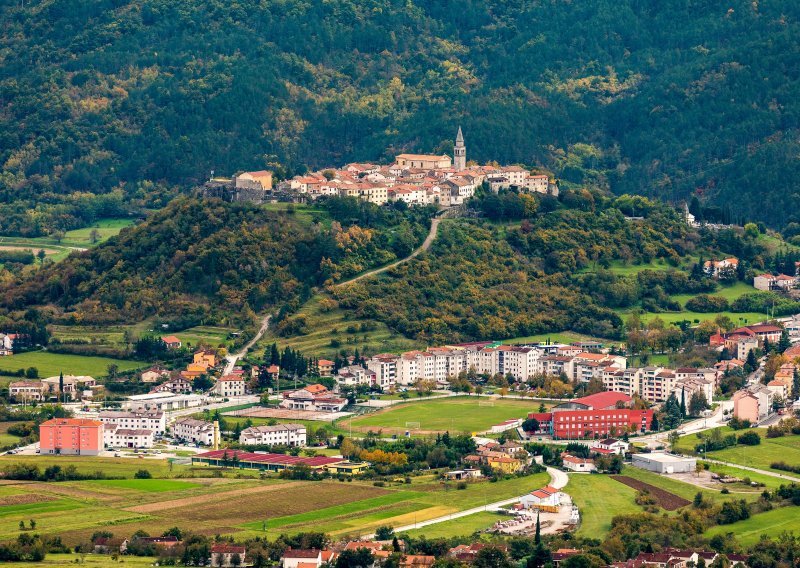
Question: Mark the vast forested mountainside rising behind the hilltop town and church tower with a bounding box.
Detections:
[0,0,800,232]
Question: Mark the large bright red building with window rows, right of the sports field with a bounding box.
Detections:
[528,391,653,440]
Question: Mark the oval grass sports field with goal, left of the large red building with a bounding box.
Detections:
[346,396,540,433]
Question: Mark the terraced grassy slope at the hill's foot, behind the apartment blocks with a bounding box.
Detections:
[253,294,425,359]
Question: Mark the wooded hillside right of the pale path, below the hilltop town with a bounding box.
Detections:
[331,190,800,344]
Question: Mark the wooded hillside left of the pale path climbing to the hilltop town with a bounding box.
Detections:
[0,198,432,328]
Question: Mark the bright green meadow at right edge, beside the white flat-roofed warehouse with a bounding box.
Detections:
[677,426,800,479]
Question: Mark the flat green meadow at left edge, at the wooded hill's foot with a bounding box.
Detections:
[0,351,147,378]
